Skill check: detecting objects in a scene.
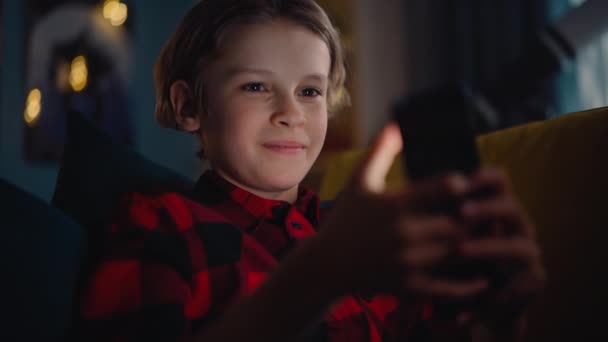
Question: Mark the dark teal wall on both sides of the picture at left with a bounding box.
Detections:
[0,0,199,200]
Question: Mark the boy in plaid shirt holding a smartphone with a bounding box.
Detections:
[81,0,543,341]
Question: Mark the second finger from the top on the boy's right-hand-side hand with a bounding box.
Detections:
[460,195,534,236]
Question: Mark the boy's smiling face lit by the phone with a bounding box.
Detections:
[201,20,331,202]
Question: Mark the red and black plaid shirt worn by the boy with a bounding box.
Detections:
[79,171,436,342]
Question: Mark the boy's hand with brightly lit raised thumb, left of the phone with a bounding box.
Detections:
[318,124,488,300]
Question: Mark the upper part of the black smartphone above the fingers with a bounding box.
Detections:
[394,87,479,181]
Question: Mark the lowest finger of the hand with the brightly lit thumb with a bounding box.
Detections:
[407,273,488,299]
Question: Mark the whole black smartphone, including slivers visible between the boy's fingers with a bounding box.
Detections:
[394,87,494,279]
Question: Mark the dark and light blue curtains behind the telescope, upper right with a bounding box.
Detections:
[404,0,608,125]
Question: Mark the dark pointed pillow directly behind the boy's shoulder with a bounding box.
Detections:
[52,112,194,253]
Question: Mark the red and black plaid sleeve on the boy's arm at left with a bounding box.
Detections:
[77,194,205,341]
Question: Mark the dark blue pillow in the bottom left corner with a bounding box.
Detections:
[0,180,86,341]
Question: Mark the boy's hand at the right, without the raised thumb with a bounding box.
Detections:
[459,169,545,322]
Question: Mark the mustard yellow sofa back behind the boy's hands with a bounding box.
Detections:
[320,107,608,341]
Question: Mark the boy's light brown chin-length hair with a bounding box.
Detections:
[154,0,349,128]
